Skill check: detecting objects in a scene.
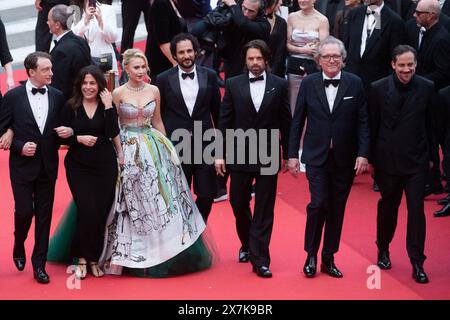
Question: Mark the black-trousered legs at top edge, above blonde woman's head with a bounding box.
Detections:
[120,0,150,53]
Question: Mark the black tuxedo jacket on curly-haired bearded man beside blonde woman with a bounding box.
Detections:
[156,66,220,152]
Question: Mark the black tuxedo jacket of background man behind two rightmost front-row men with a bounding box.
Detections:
[344,5,406,87]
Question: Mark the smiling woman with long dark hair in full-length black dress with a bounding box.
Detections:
[61,66,123,279]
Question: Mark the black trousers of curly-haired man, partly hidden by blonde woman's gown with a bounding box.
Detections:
[181,164,216,223]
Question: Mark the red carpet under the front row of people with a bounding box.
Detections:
[0,43,450,300]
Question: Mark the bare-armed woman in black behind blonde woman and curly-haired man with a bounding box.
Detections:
[145,0,187,80]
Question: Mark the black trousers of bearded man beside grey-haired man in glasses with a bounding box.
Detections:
[230,171,278,267]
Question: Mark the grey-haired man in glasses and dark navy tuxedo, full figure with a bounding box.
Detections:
[288,36,369,278]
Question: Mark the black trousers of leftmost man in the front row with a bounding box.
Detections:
[11,165,56,268]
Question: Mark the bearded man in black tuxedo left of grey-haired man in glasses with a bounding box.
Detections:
[215,40,291,278]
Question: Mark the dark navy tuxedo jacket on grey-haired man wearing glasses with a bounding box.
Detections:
[289,72,370,167]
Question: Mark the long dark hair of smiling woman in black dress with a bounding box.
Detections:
[67,65,106,111]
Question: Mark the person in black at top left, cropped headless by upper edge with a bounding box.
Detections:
[34,0,70,52]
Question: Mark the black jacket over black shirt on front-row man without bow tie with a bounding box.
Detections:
[369,75,437,175]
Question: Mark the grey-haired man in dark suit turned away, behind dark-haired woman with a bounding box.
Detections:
[48,4,91,100]
